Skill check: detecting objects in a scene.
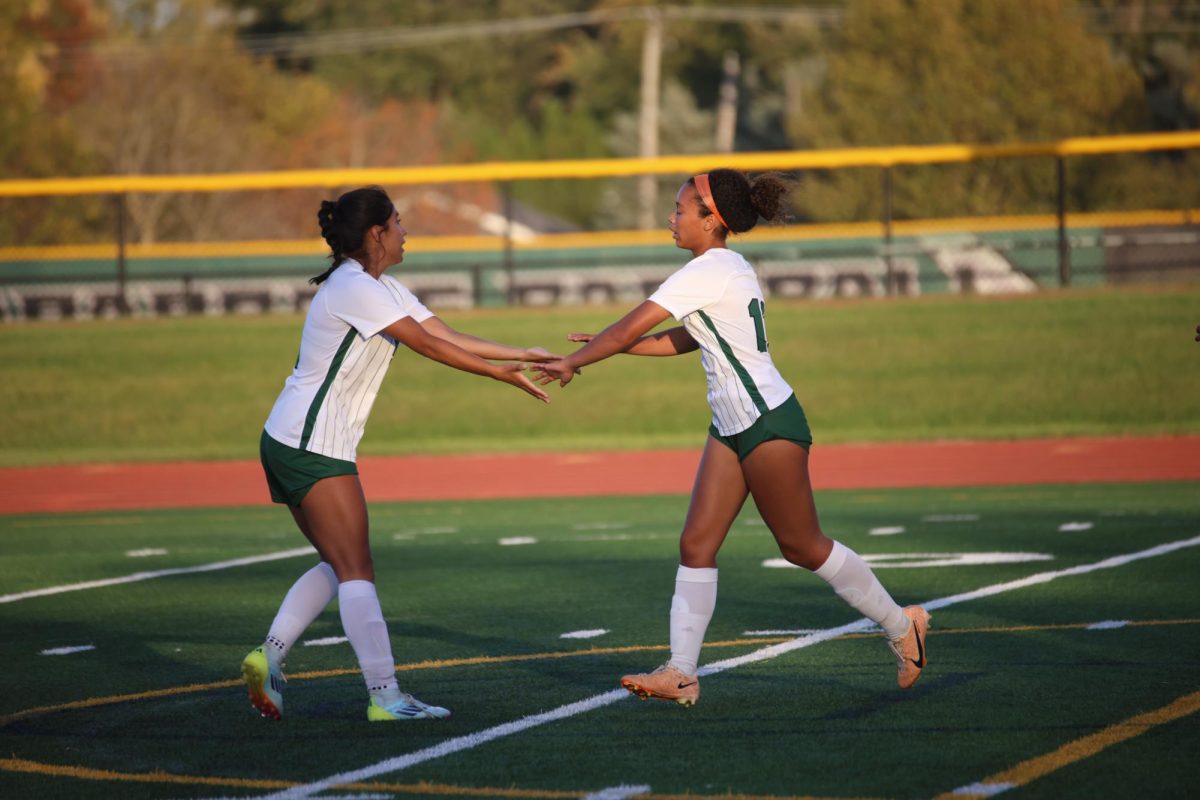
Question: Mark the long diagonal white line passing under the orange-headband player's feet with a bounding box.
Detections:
[255,536,1200,800]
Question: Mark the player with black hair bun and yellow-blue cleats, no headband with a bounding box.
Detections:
[241,186,559,722]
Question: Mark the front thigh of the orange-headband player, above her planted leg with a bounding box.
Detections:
[679,437,746,567]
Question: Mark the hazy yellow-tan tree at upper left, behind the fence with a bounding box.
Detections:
[72,0,332,243]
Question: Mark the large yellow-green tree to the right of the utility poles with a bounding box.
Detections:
[788,0,1140,219]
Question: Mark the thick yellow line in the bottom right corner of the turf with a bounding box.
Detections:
[936,692,1200,800]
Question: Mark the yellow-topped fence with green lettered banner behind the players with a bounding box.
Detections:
[0,131,1200,320]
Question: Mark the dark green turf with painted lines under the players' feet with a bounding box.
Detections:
[0,483,1200,798]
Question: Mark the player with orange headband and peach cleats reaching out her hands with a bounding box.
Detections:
[535,169,930,705]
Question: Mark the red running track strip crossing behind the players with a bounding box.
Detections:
[0,437,1200,515]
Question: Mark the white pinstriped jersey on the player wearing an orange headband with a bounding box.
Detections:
[650,247,792,437]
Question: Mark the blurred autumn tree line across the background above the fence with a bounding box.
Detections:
[0,0,1200,245]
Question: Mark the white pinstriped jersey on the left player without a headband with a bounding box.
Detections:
[265,259,433,461]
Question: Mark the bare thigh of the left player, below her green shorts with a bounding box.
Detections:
[294,475,374,581]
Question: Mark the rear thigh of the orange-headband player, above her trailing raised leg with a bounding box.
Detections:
[742,439,833,570]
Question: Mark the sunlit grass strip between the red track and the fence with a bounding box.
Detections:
[0,284,1200,467]
